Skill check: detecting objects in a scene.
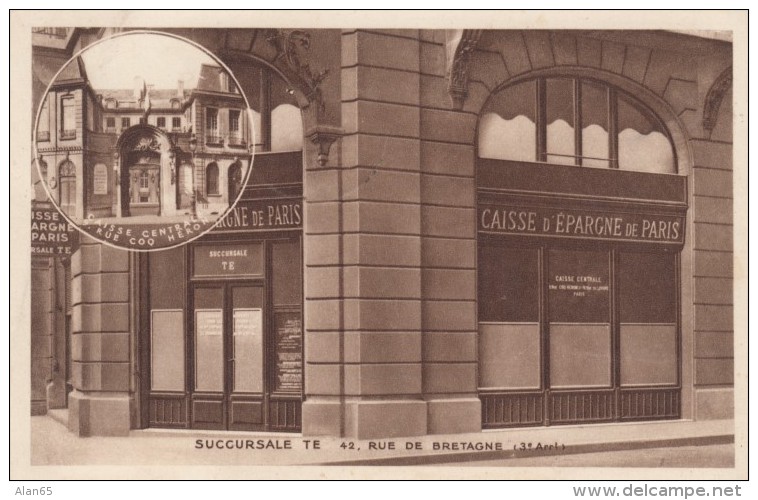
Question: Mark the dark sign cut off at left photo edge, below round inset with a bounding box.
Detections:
[31,207,79,257]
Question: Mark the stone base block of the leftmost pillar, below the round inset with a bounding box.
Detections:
[68,391,131,437]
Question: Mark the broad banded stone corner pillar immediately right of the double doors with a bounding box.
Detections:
[303,30,434,439]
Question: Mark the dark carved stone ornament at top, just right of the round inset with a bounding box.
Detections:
[266,29,329,107]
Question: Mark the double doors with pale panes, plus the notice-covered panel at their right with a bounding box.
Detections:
[189,282,302,431]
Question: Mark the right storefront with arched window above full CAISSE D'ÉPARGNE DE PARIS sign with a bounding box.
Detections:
[477,78,687,428]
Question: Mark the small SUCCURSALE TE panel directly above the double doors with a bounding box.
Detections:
[193,243,263,278]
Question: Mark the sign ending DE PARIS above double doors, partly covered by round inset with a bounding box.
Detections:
[215,199,303,231]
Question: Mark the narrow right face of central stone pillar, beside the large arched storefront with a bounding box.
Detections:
[420,30,478,434]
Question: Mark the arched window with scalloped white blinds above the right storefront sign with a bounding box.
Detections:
[479,78,676,173]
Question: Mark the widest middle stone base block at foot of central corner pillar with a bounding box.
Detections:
[345,400,427,439]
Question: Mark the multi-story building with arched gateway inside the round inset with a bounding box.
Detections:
[36,49,253,224]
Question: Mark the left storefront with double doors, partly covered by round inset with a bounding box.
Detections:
[139,153,303,432]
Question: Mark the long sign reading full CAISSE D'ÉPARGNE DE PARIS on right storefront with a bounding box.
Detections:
[478,205,684,245]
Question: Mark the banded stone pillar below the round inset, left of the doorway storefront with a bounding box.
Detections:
[68,238,131,436]
